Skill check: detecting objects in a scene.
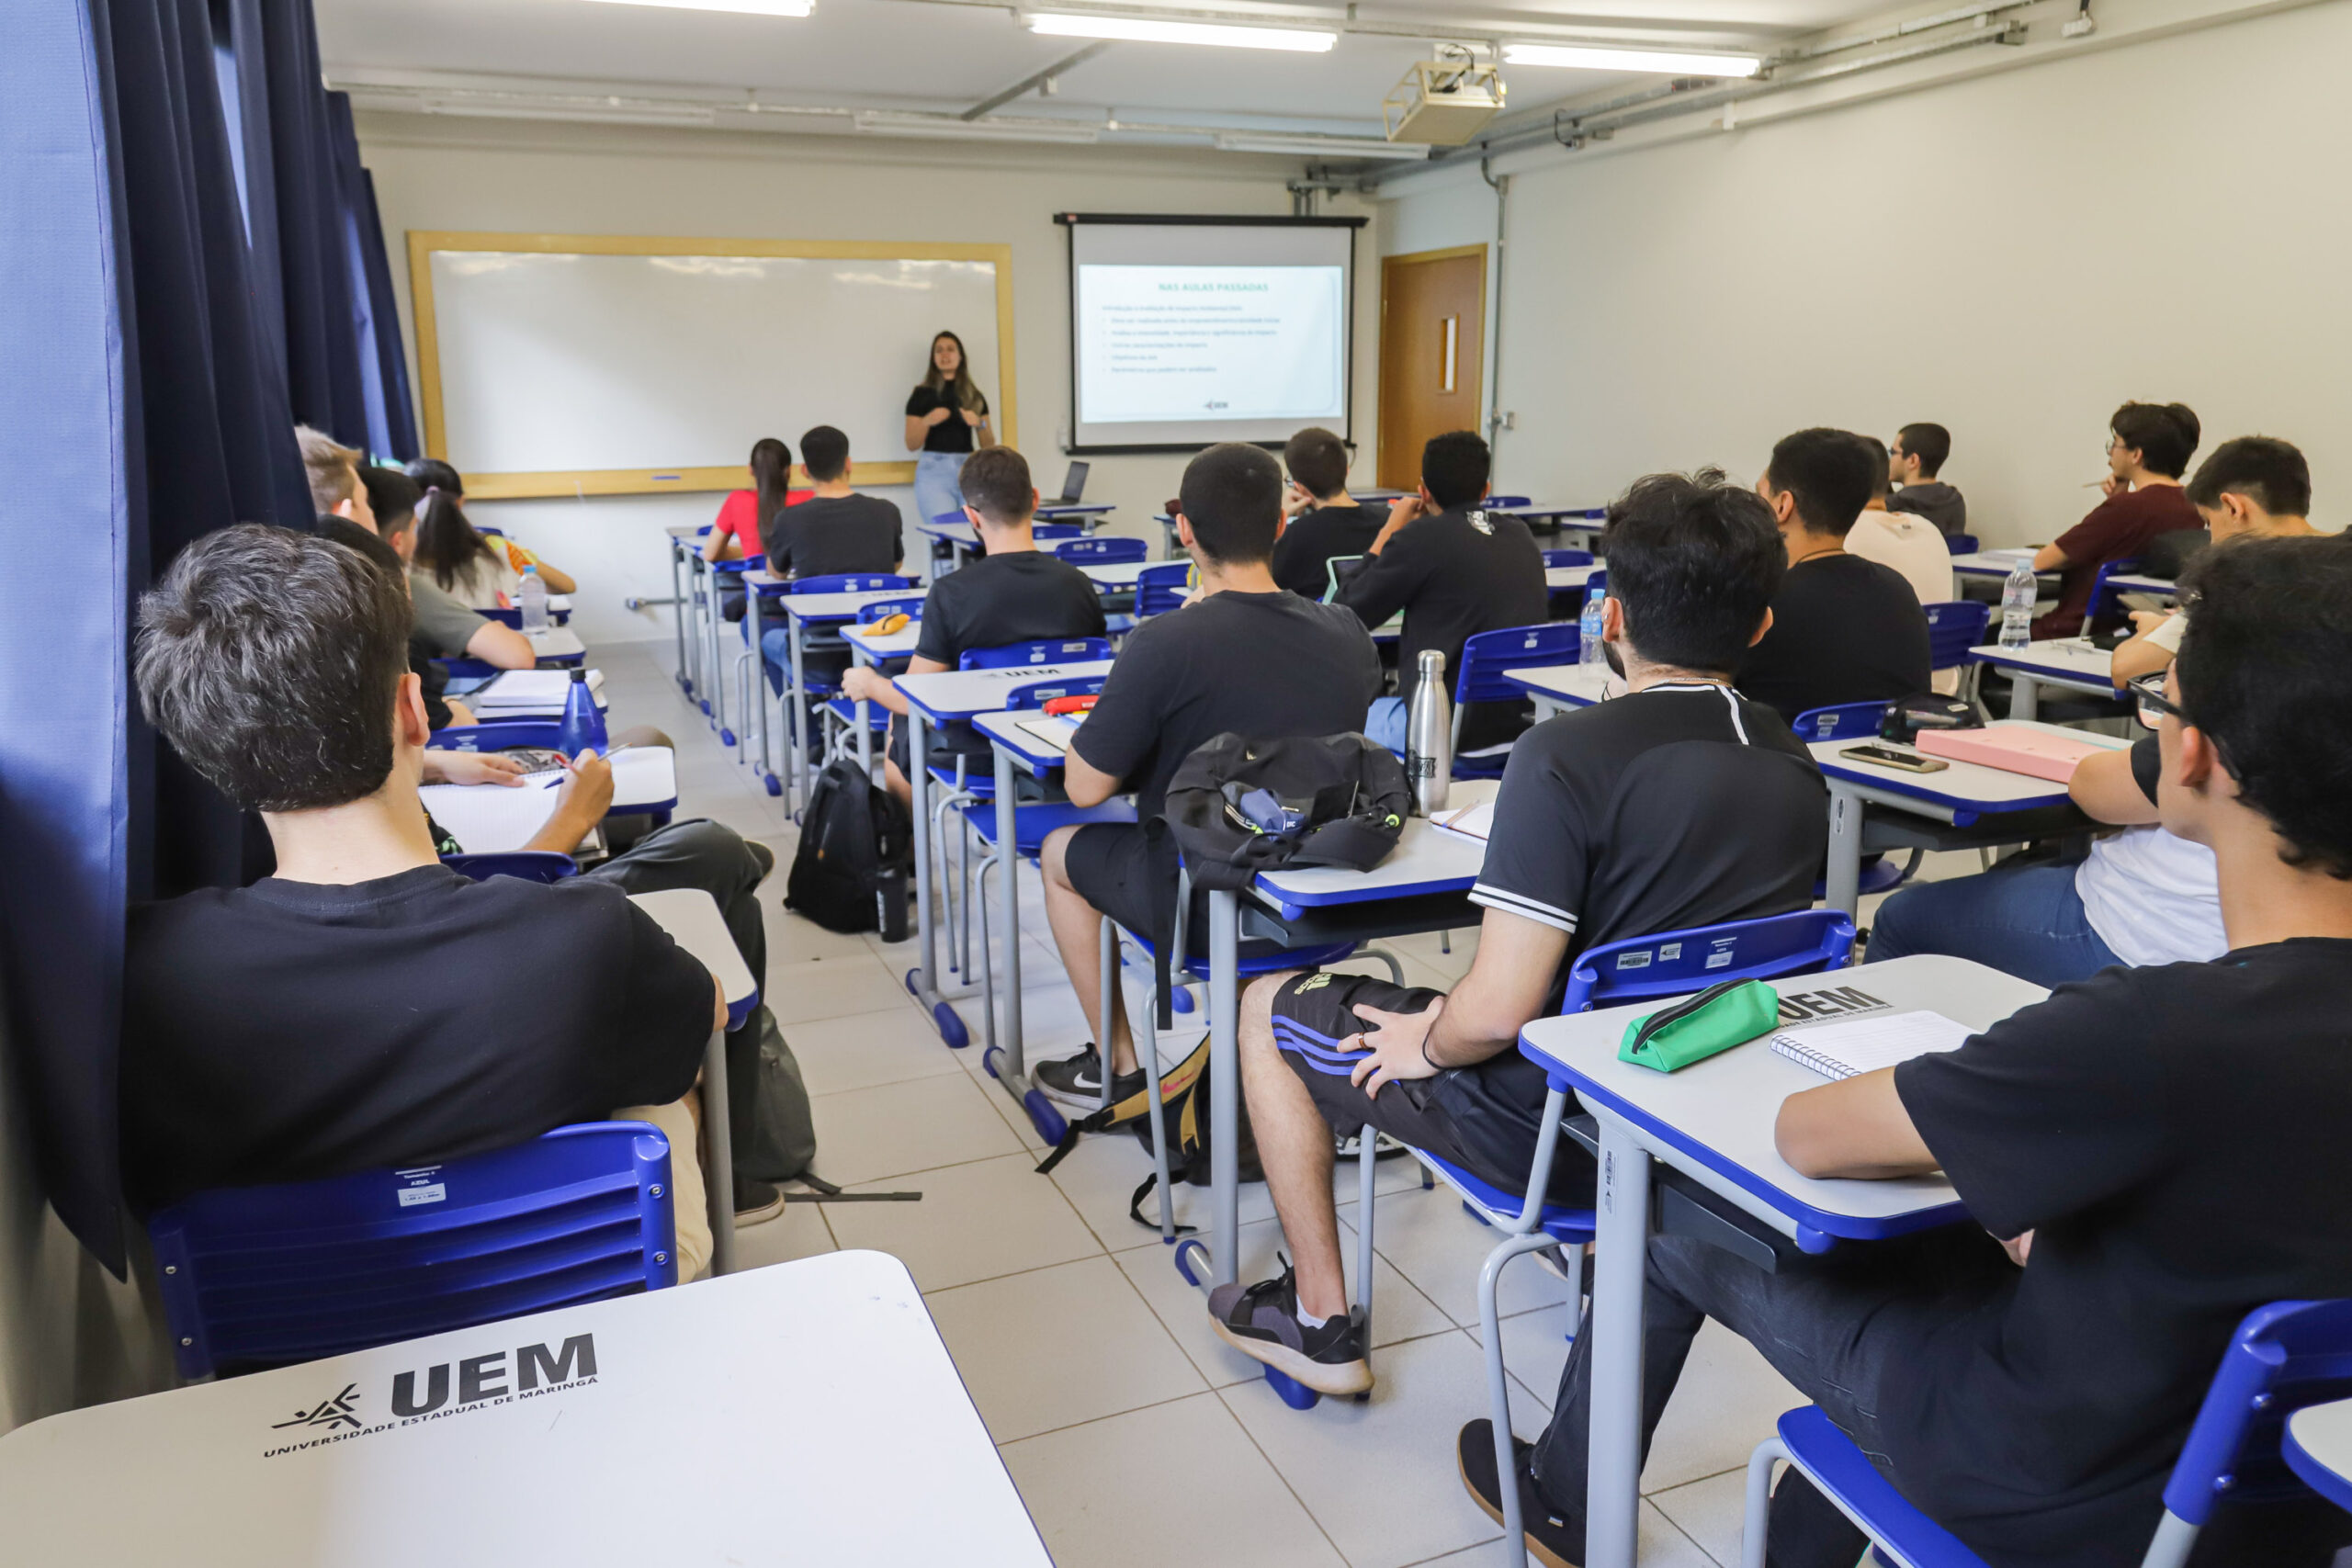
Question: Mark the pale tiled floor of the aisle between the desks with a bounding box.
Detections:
[597,644,1975,1568]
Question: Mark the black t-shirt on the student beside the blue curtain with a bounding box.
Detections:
[120,865,710,1211]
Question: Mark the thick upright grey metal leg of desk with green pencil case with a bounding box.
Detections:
[1585,1117,1649,1568]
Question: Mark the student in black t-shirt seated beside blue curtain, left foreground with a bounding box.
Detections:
[120,525,727,1277]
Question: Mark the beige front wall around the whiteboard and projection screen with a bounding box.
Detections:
[360,115,1378,642]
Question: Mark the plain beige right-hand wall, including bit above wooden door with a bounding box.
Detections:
[1385,0,2352,543]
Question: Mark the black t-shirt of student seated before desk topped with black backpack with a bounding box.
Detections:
[1077,582,1381,823]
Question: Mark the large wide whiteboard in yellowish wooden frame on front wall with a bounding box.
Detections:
[409,232,1016,499]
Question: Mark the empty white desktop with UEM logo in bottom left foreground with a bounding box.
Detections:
[0,1253,1051,1568]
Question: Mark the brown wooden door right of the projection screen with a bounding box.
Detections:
[1376,244,1487,489]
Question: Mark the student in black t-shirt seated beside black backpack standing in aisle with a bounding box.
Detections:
[842,446,1105,802]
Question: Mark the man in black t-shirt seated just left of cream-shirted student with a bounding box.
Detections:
[1740,428,1928,722]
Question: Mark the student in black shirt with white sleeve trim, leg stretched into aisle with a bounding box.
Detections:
[1209,472,1827,1394]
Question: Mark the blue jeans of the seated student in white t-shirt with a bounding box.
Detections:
[1870,863,2124,985]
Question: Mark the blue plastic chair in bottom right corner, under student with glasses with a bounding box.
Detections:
[1740,1300,2352,1568]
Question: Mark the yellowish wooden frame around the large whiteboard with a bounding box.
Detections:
[409,228,1021,501]
